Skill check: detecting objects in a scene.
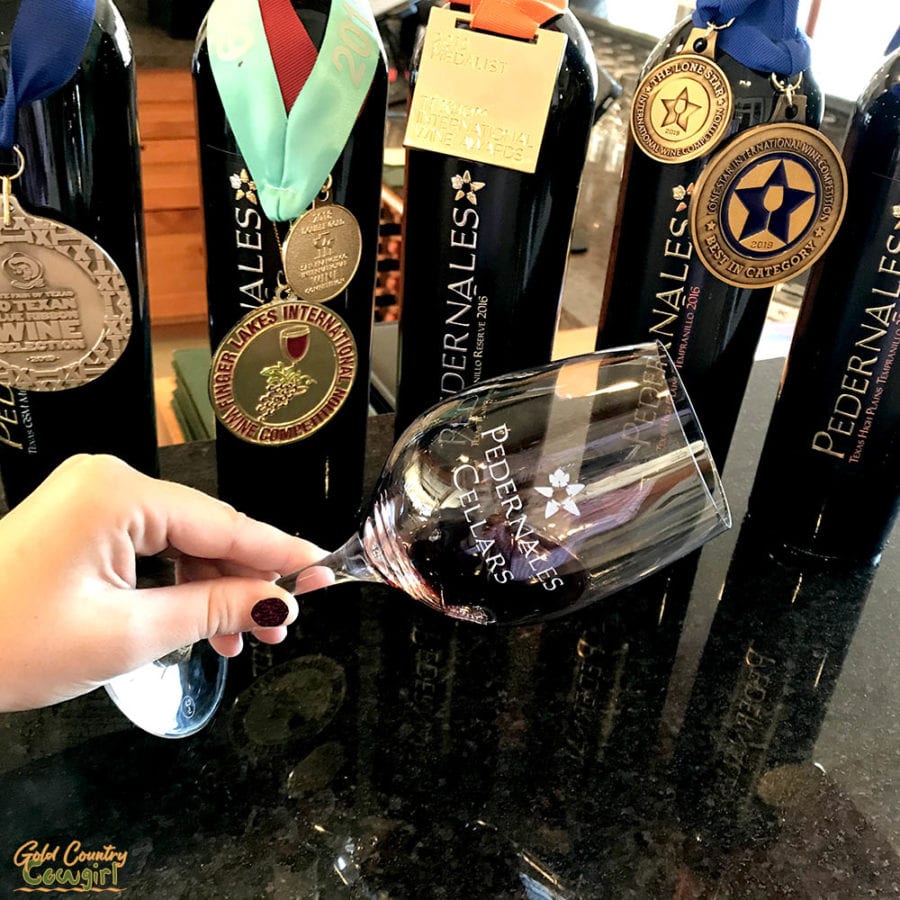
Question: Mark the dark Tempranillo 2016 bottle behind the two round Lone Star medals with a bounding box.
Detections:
[597,21,822,469]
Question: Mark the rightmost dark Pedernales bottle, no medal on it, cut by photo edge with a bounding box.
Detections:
[750,45,900,560]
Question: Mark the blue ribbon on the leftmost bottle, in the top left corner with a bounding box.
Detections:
[0,0,96,150]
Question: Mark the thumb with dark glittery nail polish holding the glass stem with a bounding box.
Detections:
[130,576,299,661]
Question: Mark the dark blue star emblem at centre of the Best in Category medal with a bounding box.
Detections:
[732,159,816,249]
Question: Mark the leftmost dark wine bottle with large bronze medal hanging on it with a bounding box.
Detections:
[0,0,158,506]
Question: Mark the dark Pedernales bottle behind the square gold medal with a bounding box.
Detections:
[397,3,597,430]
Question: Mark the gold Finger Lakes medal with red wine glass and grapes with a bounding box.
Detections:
[209,299,358,445]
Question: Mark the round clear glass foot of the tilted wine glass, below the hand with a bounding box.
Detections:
[105,641,228,738]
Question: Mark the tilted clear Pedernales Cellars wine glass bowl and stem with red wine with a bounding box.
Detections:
[278,344,731,624]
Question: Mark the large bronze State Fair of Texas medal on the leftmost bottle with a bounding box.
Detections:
[0,196,132,391]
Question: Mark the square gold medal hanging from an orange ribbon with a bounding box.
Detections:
[404,7,567,172]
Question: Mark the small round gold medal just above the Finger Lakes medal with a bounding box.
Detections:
[283,203,362,303]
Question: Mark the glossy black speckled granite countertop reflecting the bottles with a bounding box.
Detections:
[0,361,900,900]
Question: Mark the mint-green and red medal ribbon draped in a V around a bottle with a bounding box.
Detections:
[207,0,381,222]
